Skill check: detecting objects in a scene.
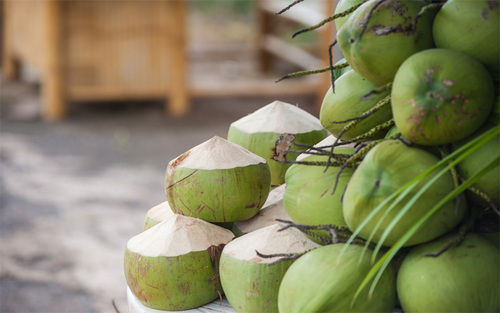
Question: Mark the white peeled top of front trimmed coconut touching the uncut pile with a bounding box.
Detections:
[222,224,319,263]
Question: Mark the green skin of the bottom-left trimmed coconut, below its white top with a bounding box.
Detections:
[124,249,218,311]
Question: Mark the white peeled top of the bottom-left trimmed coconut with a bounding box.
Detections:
[127,214,234,257]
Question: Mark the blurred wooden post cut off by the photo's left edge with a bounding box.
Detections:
[0,1,19,79]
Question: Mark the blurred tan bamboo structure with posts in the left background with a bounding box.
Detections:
[2,0,188,120]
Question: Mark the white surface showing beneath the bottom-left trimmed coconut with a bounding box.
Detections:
[127,286,236,313]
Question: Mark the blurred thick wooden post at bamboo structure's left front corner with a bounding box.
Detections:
[42,0,66,120]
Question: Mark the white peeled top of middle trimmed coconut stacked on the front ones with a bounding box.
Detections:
[167,136,266,174]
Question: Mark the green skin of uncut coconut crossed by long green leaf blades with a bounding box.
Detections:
[343,140,465,246]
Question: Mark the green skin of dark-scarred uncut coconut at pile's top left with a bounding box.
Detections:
[337,0,435,85]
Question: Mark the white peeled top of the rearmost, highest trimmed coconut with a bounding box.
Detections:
[231,101,323,134]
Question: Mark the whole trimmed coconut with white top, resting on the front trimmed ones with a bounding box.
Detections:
[165,136,270,222]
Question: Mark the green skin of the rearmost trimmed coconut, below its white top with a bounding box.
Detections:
[227,125,328,186]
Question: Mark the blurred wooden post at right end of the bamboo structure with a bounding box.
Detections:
[166,0,190,116]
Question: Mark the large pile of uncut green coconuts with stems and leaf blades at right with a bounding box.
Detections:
[273,0,500,312]
